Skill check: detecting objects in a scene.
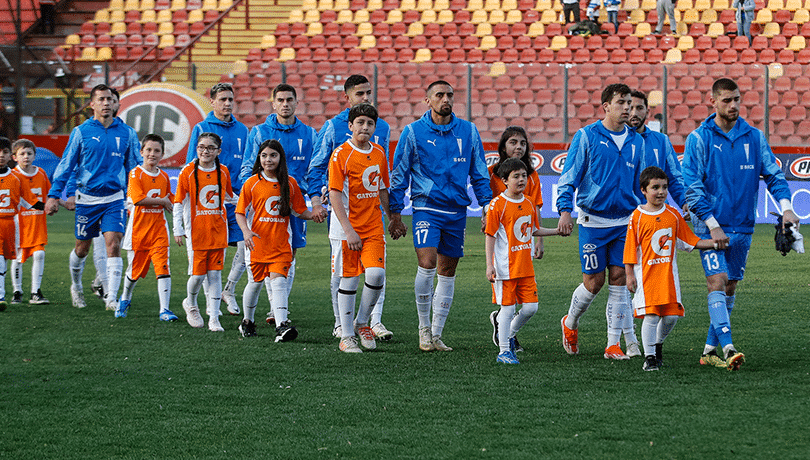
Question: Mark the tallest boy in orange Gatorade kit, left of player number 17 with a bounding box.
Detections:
[329,104,391,353]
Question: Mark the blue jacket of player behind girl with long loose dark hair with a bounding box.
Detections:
[239,113,315,195]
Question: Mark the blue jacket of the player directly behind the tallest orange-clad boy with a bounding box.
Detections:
[306,109,391,201]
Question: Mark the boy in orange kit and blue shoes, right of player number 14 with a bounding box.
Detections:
[115,134,177,321]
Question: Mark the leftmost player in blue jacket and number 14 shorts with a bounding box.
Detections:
[45,85,141,310]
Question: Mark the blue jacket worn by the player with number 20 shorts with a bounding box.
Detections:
[557,120,646,219]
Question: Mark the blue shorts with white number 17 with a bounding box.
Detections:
[413,209,467,258]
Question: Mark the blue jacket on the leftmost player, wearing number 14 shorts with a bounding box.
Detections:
[48,117,143,199]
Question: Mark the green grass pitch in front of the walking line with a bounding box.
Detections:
[0,211,810,459]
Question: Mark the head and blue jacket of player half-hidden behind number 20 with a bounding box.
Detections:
[627,90,689,215]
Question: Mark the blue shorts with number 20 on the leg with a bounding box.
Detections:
[579,225,627,275]
